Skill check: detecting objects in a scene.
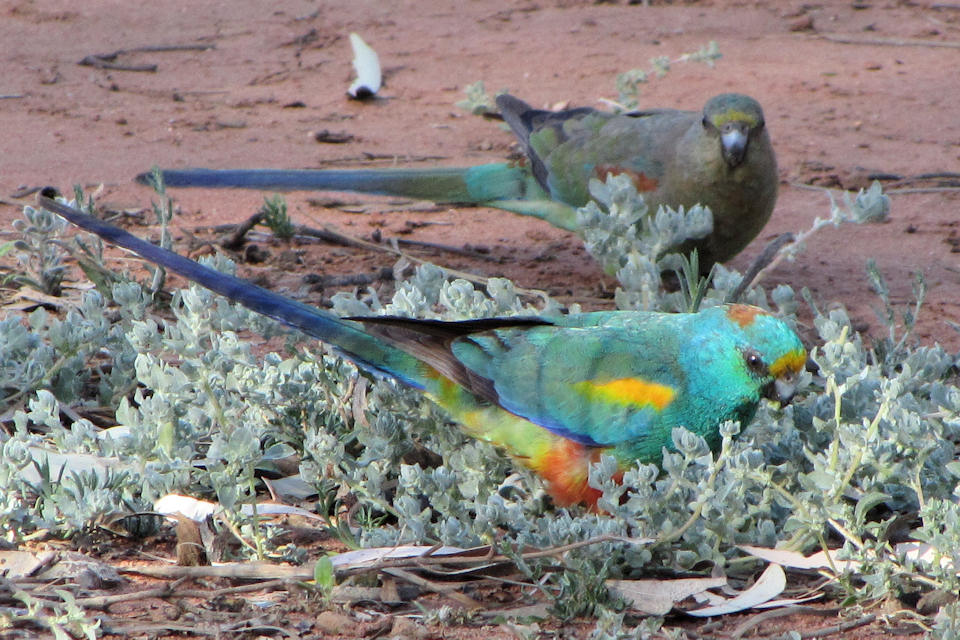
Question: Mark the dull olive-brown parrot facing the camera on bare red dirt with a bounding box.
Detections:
[144,93,778,270]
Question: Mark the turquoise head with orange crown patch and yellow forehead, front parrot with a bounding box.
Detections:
[726,304,807,404]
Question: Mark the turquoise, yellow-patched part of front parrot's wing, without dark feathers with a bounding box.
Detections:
[451,326,685,446]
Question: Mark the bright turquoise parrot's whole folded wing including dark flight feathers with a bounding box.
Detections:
[350,312,685,446]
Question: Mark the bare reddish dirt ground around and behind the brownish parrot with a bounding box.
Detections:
[0,0,960,637]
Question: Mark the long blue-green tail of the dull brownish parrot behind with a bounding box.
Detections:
[137,163,577,231]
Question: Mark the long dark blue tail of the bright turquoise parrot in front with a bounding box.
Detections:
[37,196,435,389]
